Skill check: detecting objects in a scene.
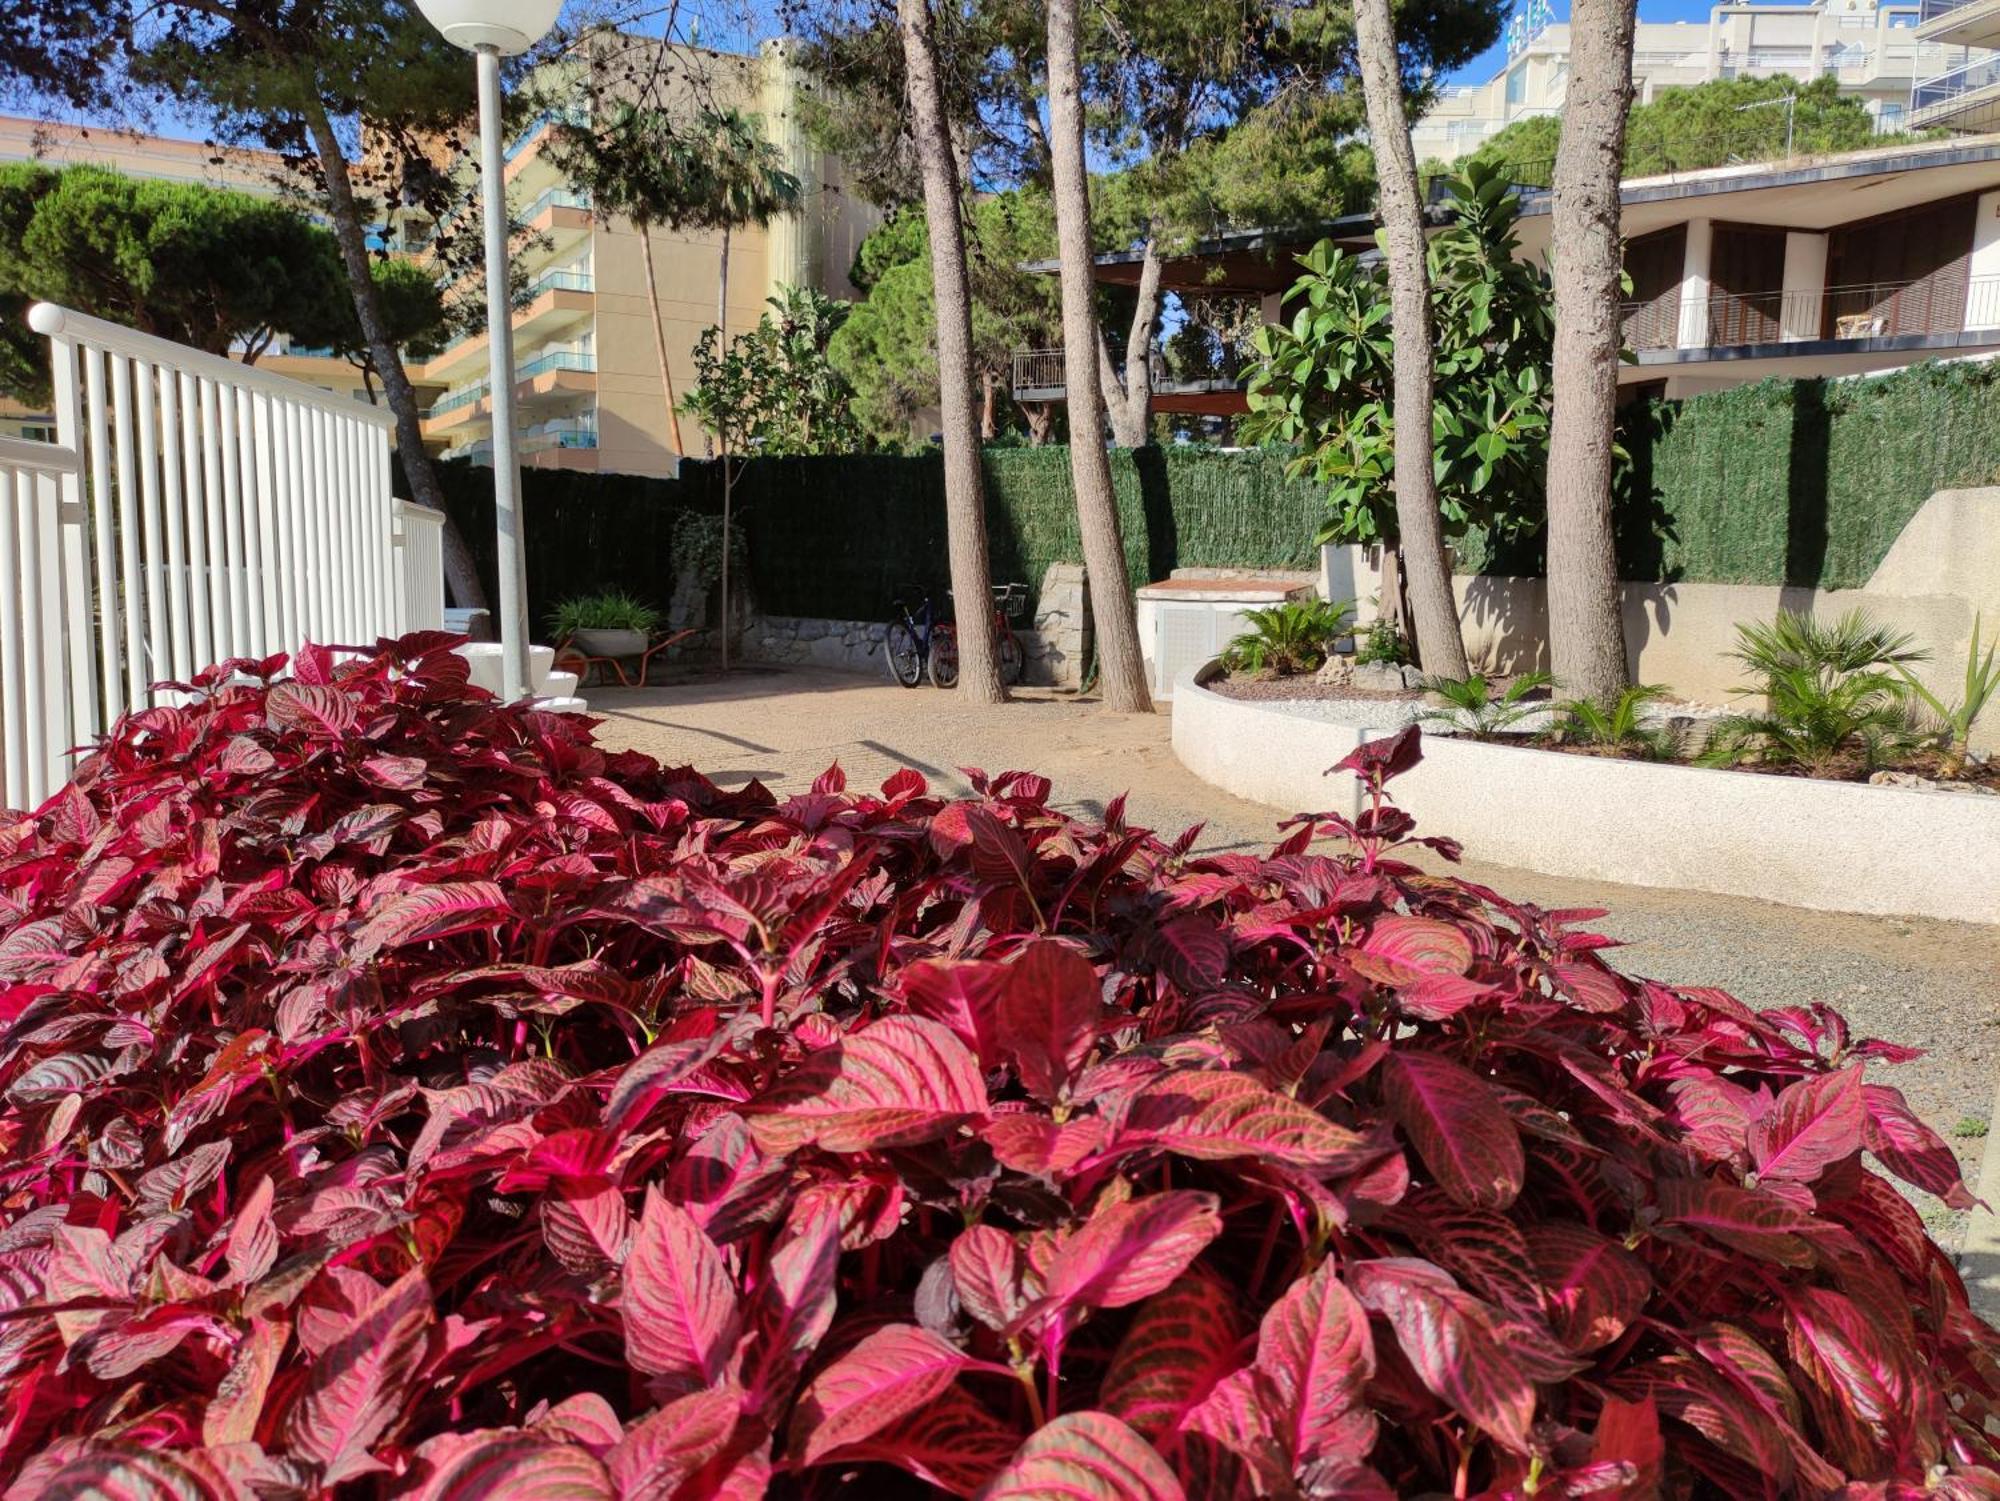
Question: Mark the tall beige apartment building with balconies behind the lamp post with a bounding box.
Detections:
[404,42,880,474]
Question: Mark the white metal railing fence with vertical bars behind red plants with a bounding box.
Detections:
[0,302,444,809]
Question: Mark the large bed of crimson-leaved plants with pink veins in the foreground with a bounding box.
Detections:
[0,636,2000,1501]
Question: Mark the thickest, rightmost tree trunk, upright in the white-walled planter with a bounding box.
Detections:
[1548,0,1636,702]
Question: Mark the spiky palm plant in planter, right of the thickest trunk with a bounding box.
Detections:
[1700,610,1928,777]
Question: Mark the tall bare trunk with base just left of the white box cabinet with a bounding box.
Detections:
[1056,0,1152,714]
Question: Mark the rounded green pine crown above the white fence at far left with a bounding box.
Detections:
[0,162,352,402]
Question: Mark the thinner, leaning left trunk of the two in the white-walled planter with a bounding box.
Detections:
[1354,0,1466,678]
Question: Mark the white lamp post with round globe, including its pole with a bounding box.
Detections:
[416,0,562,702]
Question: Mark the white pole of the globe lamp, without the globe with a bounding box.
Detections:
[474,44,528,702]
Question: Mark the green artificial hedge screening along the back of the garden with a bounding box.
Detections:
[440,364,2000,626]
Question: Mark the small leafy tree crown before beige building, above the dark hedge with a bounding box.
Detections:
[680,286,862,456]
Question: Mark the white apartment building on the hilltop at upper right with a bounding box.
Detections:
[1412,0,1960,162]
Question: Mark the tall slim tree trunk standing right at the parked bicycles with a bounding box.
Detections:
[896,0,1006,704]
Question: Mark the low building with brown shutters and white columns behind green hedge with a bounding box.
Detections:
[1014,134,2000,418]
